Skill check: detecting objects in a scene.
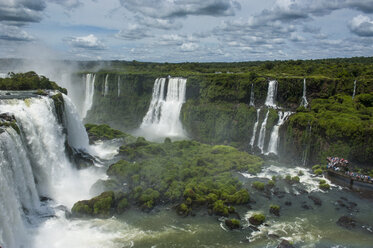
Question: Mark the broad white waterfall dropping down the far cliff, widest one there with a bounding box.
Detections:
[139,77,187,140]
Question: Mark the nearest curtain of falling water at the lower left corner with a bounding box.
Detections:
[0,128,40,247]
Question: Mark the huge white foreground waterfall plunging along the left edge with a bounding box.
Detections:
[0,93,110,248]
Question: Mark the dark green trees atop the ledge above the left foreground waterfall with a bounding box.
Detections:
[0,71,67,95]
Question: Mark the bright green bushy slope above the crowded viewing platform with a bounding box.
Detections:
[286,93,373,166]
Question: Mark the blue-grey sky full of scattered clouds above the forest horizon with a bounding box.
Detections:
[0,0,373,62]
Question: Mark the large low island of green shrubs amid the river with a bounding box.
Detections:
[75,134,262,216]
